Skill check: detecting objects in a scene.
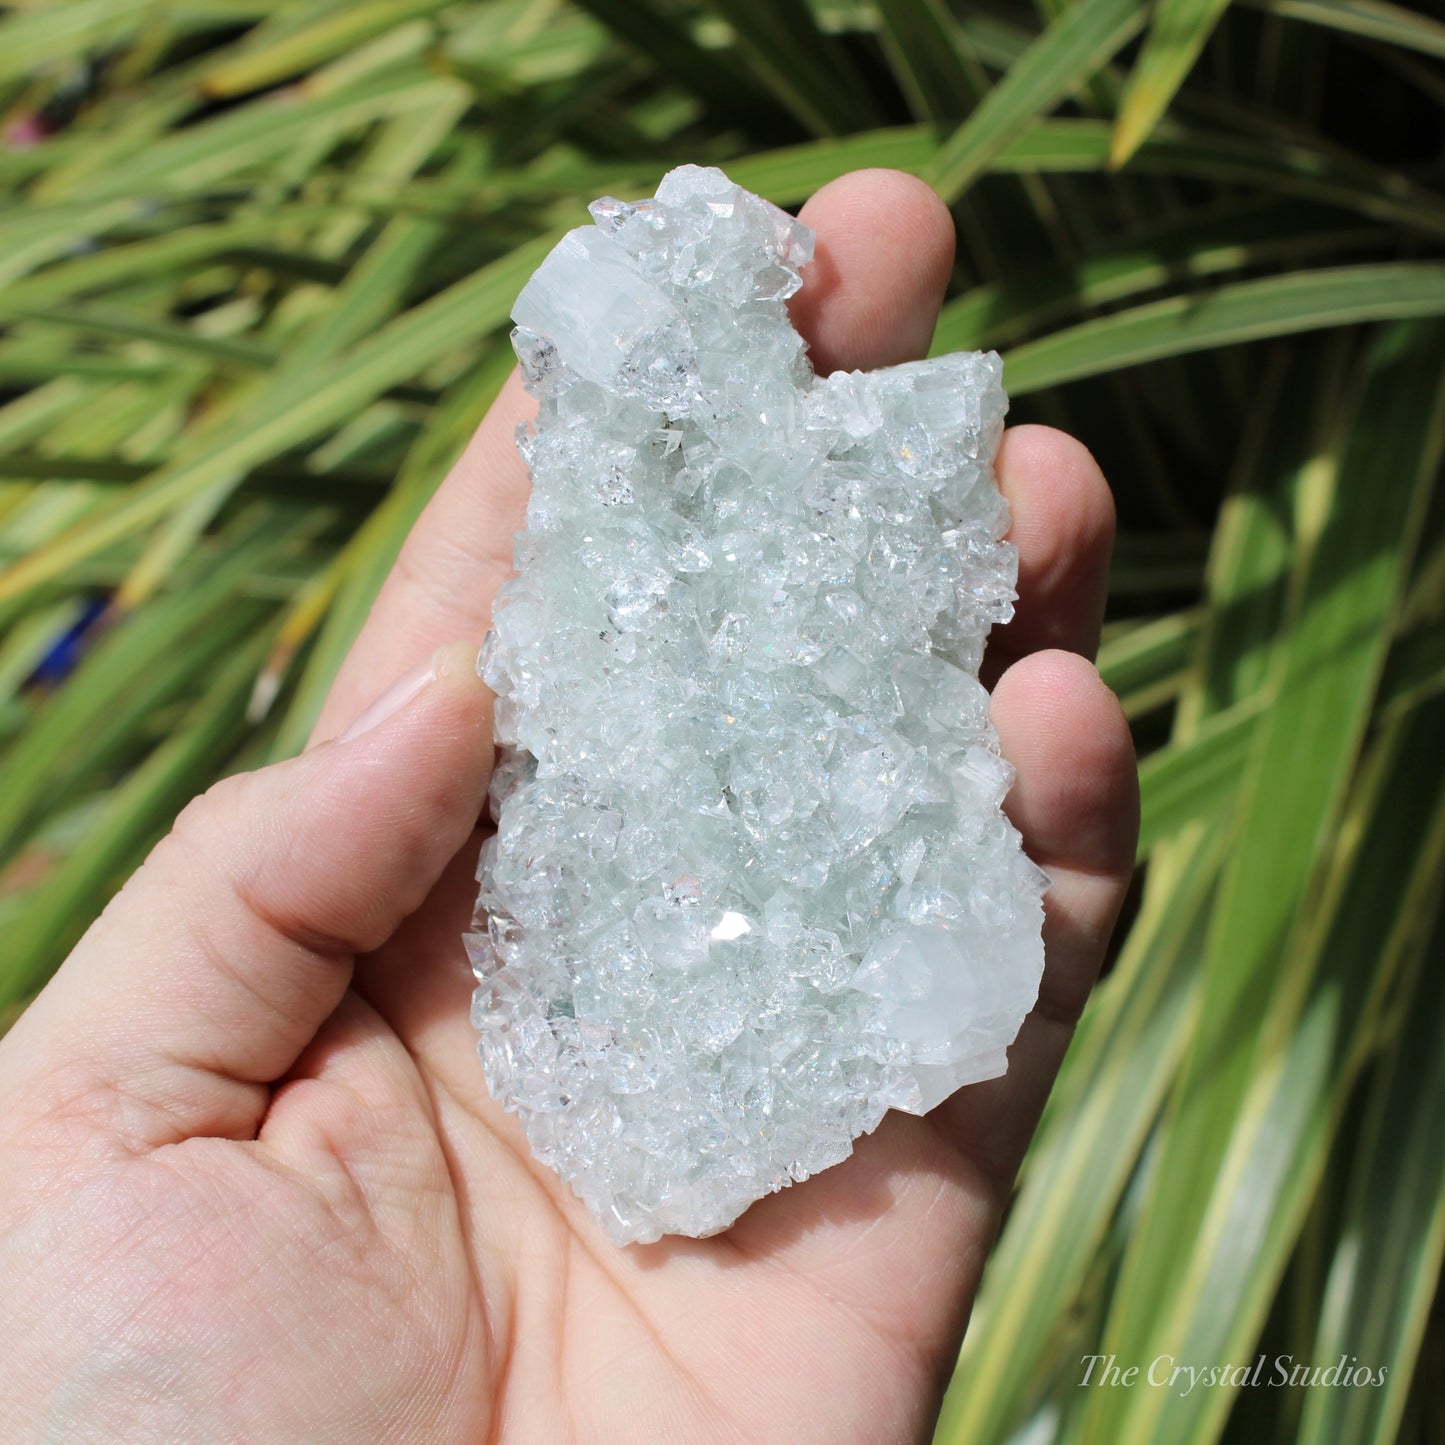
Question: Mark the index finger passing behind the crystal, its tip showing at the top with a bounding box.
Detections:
[314,171,954,738]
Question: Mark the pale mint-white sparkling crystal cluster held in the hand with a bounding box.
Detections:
[468,166,1046,1243]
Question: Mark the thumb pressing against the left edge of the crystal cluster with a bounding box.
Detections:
[0,643,493,1147]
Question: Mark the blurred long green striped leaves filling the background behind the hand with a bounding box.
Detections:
[0,0,1445,1445]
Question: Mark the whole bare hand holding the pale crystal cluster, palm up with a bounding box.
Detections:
[0,171,1137,1445]
